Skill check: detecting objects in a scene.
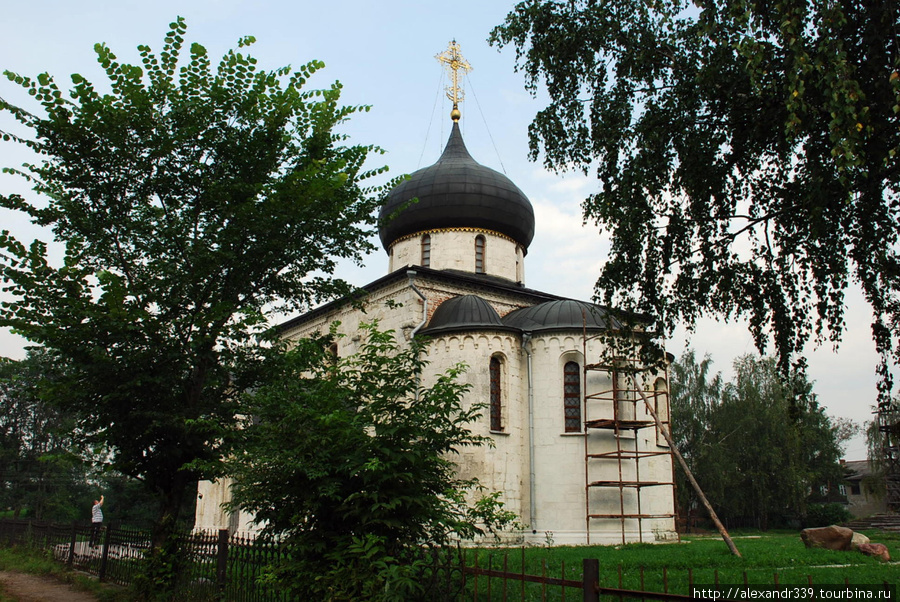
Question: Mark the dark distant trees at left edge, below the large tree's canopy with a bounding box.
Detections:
[0,347,94,521]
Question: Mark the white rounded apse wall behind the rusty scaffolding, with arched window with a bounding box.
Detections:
[531,333,675,544]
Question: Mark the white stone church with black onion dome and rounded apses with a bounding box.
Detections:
[195,98,677,545]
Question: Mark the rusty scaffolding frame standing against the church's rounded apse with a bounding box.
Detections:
[582,329,675,544]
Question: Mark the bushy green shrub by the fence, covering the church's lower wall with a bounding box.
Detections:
[233,326,513,600]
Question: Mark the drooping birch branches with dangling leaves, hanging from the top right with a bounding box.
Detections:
[490,0,900,403]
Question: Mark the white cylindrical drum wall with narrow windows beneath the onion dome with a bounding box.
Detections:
[388,228,525,282]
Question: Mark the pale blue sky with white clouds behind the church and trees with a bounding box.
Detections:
[0,0,877,460]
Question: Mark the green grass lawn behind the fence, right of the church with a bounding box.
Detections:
[466,531,900,599]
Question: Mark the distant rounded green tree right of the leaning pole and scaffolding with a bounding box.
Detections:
[671,352,843,529]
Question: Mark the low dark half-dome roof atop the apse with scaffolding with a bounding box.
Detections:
[503,299,621,332]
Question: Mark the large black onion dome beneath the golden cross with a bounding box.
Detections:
[379,122,534,251]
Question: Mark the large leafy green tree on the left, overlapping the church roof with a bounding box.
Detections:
[0,18,383,572]
